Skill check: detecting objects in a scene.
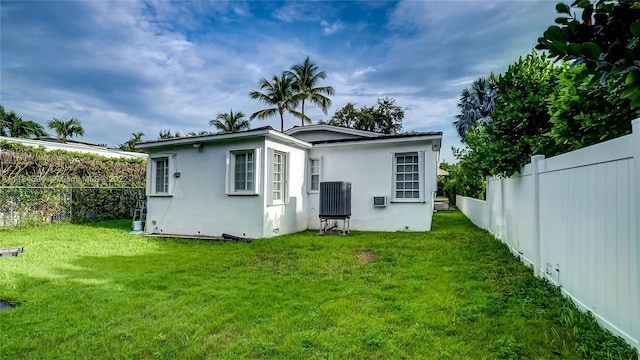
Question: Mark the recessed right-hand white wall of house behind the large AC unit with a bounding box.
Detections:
[306,140,438,231]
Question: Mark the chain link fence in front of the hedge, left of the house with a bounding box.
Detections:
[0,186,145,229]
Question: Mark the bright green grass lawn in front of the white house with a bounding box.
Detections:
[0,212,637,359]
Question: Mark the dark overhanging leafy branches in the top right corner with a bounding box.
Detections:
[536,0,640,112]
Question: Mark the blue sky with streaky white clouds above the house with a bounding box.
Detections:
[0,0,556,162]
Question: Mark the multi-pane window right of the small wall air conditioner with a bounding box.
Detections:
[393,152,422,202]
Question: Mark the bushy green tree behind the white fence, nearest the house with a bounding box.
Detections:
[465,51,566,176]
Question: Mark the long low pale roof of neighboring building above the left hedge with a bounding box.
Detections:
[0,136,147,159]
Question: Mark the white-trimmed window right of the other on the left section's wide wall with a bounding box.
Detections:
[226,149,260,195]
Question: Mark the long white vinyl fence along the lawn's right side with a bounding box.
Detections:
[456,119,640,350]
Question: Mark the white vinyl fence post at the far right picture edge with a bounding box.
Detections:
[631,118,640,352]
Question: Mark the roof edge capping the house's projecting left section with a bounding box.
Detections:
[136,126,311,149]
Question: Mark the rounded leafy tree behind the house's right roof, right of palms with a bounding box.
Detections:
[326,98,404,134]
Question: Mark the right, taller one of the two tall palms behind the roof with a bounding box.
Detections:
[289,56,334,126]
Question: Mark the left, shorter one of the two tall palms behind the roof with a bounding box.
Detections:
[249,71,303,132]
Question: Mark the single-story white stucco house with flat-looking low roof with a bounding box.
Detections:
[137,125,442,238]
